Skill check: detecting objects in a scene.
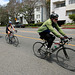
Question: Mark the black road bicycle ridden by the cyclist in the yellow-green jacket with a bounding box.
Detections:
[33,38,75,71]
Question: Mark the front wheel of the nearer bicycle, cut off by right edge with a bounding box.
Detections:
[56,47,75,71]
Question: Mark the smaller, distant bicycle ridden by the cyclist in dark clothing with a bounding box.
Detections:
[5,30,19,47]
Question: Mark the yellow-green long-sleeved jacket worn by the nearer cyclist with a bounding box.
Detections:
[37,19,65,38]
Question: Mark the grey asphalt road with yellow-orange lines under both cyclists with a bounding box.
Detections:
[0,27,75,75]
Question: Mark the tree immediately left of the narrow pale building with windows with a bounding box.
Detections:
[19,0,38,23]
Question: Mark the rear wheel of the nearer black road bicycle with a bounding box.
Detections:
[33,42,47,59]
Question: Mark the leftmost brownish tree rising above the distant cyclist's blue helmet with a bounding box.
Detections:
[7,1,22,23]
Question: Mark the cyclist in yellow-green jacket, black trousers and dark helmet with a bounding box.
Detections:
[38,13,68,49]
